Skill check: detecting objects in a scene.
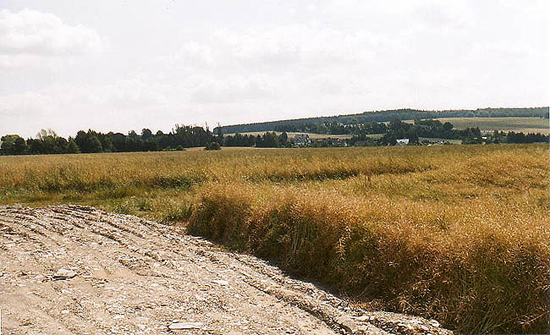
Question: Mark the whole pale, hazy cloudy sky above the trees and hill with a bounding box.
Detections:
[0,0,550,137]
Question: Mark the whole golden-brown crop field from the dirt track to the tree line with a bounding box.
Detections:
[0,145,550,333]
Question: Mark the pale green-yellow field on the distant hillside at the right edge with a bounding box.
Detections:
[438,117,550,135]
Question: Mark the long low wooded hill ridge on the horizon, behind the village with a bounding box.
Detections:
[215,107,549,134]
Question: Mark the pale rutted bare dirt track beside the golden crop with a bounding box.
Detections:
[0,206,450,334]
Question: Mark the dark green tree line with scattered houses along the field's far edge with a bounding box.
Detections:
[0,119,549,155]
